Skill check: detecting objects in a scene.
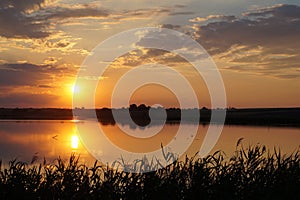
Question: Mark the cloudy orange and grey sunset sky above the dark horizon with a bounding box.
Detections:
[0,0,300,108]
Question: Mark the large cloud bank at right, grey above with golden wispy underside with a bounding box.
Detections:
[191,5,300,78]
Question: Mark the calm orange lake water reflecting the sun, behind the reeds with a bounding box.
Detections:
[0,121,300,163]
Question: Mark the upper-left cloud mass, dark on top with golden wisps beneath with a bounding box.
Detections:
[0,0,177,64]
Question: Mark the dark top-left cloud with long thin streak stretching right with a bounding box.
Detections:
[0,0,173,39]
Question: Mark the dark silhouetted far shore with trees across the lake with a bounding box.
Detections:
[0,104,300,127]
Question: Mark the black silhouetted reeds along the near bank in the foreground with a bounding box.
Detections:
[0,142,300,199]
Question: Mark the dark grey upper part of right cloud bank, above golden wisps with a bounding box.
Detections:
[195,5,300,53]
